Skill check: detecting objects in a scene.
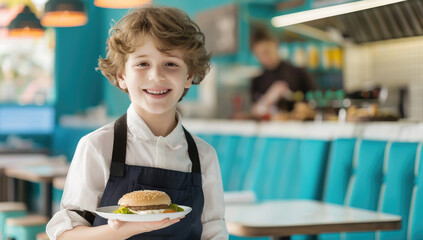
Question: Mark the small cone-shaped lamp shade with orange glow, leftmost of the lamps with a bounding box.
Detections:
[7,6,44,37]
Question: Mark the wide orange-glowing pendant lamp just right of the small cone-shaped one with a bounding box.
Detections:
[41,0,88,27]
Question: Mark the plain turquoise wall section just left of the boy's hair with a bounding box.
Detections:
[54,0,103,118]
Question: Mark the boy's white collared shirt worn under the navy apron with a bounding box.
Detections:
[46,105,228,240]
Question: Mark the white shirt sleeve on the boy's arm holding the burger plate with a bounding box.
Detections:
[46,136,113,240]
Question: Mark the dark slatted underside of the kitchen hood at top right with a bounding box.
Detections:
[304,0,423,44]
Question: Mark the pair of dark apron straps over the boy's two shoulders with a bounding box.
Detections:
[110,113,201,177]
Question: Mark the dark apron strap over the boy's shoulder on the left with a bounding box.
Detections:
[110,113,127,177]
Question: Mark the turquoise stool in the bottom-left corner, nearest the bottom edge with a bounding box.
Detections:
[4,215,48,240]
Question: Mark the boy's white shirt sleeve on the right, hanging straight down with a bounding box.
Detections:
[196,139,229,240]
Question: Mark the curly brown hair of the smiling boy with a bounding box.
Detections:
[97,5,210,97]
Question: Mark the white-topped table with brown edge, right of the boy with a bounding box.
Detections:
[225,200,401,237]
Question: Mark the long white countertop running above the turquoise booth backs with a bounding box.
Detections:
[183,119,423,142]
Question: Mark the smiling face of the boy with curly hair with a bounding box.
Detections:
[117,37,193,115]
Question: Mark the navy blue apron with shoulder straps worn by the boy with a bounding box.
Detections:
[93,114,204,240]
